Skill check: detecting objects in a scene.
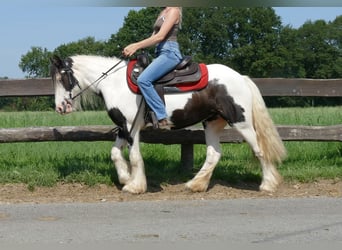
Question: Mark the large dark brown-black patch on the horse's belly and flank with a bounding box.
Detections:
[171,80,245,129]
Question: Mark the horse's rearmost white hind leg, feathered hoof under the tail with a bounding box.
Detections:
[235,123,282,192]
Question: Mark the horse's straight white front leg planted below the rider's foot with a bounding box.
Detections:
[122,131,147,194]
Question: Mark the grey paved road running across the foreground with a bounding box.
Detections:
[0,198,342,246]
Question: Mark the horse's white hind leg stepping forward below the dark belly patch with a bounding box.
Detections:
[186,119,227,192]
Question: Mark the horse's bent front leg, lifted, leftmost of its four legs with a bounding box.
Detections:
[111,138,131,185]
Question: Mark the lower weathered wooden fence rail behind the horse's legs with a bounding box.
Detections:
[0,125,342,145]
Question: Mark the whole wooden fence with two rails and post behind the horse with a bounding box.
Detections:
[0,78,342,169]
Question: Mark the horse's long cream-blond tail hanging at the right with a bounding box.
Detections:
[245,76,286,164]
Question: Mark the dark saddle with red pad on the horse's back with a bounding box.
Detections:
[127,54,208,94]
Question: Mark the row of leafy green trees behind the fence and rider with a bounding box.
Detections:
[9,7,342,109]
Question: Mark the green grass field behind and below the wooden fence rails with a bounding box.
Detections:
[0,107,342,188]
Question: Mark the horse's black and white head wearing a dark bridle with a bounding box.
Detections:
[50,56,78,114]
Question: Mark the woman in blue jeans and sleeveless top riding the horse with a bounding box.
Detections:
[122,7,182,128]
